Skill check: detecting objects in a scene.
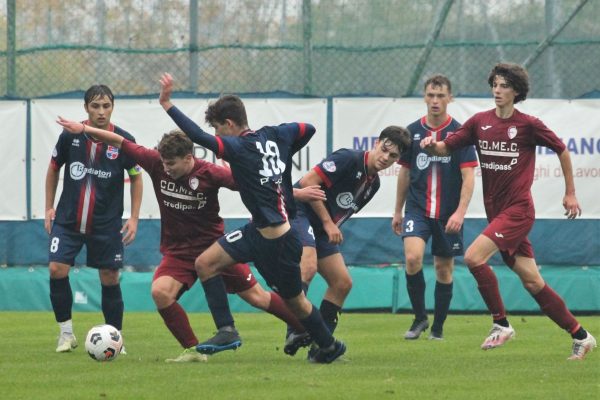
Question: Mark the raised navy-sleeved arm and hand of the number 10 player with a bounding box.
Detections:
[158,72,219,155]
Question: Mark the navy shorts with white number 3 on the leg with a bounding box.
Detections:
[402,214,464,257]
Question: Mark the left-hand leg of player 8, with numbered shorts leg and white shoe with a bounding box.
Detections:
[48,224,83,353]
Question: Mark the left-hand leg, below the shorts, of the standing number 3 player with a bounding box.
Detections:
[403,236,429,340]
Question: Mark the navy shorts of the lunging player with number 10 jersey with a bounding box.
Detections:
[218,222,302,299]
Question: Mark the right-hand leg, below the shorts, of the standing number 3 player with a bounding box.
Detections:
[429,256,454,339]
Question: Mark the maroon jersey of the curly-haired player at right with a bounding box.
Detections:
[444,109,565,218]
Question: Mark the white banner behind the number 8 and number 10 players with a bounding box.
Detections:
[30,99,327,218]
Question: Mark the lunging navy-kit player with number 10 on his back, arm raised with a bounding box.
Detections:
[159,73,346,363]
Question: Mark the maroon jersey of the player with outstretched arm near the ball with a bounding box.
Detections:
[122,140,237,260]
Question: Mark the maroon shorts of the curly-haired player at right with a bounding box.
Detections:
[483,206,535,268]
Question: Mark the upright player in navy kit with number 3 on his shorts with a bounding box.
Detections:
[392,75,477,340]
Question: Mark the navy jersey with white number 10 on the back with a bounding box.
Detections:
[168,106,315,228]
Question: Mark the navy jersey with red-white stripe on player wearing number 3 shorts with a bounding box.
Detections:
[398,116,477,219]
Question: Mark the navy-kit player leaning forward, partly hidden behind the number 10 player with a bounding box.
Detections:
[287,126,410,350]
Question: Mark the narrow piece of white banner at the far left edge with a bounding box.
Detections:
[0,101,27,221]
